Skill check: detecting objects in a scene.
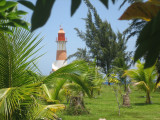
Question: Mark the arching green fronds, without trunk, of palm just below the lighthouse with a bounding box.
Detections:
[43,60,90,99]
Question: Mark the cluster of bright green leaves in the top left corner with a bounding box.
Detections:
[0,0,29,34]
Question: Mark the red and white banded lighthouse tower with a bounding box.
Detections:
[52,27,67,72]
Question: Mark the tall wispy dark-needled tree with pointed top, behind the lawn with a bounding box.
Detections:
[75,0,130,86]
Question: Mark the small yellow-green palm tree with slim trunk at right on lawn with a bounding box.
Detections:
[124,60,157,104]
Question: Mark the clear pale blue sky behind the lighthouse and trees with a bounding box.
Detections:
[18,0,136,75]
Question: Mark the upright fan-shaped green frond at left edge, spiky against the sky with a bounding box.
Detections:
[0,28,43,88]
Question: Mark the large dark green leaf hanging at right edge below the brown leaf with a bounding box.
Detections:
[134,12,160,68]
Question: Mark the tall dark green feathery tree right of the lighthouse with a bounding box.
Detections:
[75,0,125,85]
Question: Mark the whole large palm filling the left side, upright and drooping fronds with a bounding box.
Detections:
[0,28,67,120]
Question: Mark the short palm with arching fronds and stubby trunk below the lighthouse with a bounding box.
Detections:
[43,60,91,116]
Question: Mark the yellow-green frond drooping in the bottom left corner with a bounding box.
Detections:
[0,83,41,120]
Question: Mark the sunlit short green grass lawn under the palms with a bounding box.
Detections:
[58,86,160,120]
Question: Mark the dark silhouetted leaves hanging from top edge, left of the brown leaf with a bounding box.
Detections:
[18,0,115,31]
